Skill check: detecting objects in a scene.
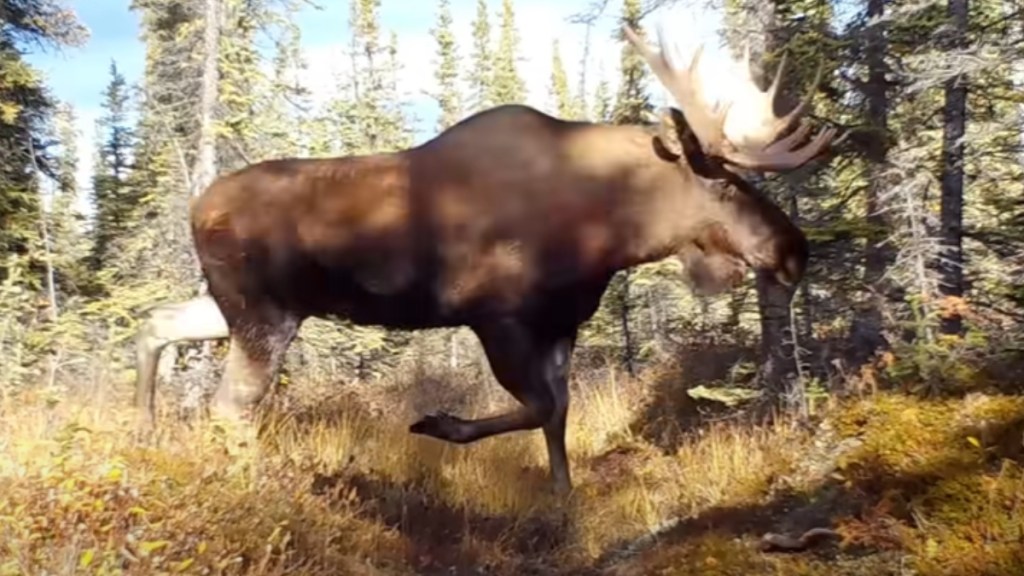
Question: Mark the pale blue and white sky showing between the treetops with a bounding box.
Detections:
[27,0,720,212]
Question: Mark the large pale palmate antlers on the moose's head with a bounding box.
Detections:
[623,26,836,172]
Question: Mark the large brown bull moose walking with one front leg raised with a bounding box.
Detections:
[135,27,835,494]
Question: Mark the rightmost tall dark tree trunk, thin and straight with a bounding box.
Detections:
[938,0,968,334]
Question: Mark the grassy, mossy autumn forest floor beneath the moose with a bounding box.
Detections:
[0,356,1024,576]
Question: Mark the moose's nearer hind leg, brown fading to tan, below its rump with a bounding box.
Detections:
[211,313,299,420]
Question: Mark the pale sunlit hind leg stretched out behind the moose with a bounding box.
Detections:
[134,295,228,426]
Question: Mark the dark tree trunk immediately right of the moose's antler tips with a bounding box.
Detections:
[851,0,895,364]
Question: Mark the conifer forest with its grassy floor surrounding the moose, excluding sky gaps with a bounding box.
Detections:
[0,0,1024,576]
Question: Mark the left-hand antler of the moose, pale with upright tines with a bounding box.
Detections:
[623,25,729,156]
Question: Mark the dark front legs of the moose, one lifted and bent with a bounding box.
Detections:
[409,319,575,493]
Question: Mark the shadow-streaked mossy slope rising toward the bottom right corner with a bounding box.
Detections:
[589,389,1024,576]
